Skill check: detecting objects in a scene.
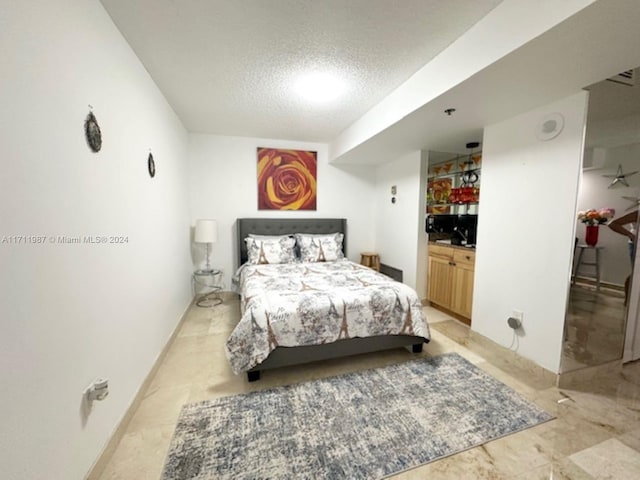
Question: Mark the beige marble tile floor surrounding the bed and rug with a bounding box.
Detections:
[96,294,640,480]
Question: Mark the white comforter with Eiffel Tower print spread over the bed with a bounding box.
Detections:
[226,260,430,373]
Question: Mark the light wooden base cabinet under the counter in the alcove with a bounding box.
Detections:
[427,244,476,321]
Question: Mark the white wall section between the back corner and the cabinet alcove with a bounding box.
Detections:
[375,151,427,298]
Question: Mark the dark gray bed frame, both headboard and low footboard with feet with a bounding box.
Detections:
[236,218,425,382]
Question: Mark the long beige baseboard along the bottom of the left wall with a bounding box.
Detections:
[85,296,197,480]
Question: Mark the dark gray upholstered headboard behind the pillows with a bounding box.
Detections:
[236,218,347,267]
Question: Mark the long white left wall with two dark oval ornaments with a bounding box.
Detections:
[0,0,191,480]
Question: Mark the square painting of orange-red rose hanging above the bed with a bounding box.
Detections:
[258,148,318,210]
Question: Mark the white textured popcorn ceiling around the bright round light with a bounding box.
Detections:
[101,0,501,142]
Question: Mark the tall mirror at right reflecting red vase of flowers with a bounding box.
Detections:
[560,69,640,373]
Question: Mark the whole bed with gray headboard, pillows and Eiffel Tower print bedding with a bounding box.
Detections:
[226,218,430,381]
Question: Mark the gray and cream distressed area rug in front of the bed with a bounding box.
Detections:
[162,353,553,480]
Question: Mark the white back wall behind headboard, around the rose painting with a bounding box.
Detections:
[189,134,375,282]
